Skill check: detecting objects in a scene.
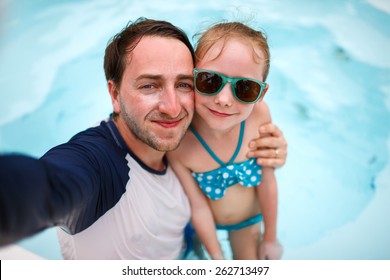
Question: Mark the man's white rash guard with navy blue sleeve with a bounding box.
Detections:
[0,117,190,259]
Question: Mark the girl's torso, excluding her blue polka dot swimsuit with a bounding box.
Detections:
[178,104,269,225]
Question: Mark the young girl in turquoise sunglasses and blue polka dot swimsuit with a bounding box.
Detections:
[169,22,282,259]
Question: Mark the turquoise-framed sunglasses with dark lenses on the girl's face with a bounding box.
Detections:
[194,68,267,104]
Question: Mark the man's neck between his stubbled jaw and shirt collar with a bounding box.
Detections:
[114,116,166,171]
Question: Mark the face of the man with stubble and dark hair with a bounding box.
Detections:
[113,36,194,151]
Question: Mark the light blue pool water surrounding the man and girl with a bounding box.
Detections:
[0,0,390,259]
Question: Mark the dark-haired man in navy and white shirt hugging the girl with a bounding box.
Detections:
[0,19,286,259]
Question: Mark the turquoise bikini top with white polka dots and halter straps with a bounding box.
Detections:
[190,122,262,200]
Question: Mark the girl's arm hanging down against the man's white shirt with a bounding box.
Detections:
[170,156,224,259]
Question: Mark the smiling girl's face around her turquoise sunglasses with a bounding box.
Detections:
[195,38,268,130]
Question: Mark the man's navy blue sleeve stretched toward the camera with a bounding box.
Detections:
[0,121,129,245]
